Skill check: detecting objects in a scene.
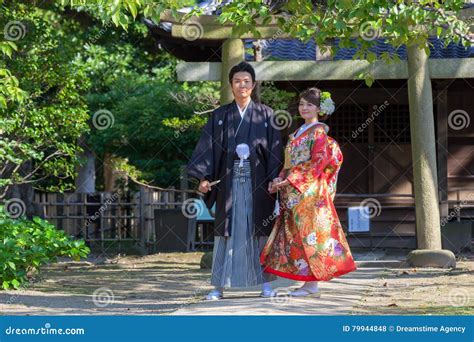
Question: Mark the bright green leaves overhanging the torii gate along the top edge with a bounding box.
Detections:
[219,0,469,50]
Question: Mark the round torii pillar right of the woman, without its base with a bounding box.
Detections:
[407,45,441,250]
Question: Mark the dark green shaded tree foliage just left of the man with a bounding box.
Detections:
[89,65,218,187]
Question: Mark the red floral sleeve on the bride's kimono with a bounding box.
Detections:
[286,127,328,193]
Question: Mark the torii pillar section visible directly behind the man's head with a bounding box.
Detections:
[220,38,245,106]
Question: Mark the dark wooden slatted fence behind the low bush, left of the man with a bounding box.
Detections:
[34,187,195,253]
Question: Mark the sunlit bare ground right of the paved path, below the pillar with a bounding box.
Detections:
[352,255,474,315]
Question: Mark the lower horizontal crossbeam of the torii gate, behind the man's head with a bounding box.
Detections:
[177,58,474,81]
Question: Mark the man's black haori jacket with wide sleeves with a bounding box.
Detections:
[187,101,283,236]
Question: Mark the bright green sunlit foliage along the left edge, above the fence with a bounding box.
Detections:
[0,3,89,198]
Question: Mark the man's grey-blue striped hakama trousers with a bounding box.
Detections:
[211,160,275,287]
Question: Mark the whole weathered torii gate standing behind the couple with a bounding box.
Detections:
[161,11,474,267]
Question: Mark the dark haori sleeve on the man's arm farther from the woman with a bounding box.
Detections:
[187,114,215,180]
